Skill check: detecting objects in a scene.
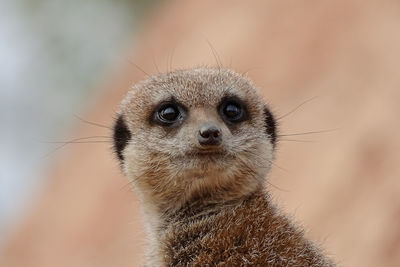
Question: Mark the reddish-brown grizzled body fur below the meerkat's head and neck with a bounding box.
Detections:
[159,192,334,266]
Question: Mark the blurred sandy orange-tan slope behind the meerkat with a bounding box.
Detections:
[0,0,400,267]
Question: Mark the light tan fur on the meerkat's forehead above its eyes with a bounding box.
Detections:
[120,67,263,120]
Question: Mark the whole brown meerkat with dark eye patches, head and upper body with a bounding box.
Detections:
[113,67,335,266]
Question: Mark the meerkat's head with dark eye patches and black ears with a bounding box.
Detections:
[114,68,276,215]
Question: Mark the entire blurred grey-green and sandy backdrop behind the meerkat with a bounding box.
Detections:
[0,0,400,267]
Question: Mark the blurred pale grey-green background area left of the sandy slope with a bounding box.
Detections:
[0,0,156,244]
